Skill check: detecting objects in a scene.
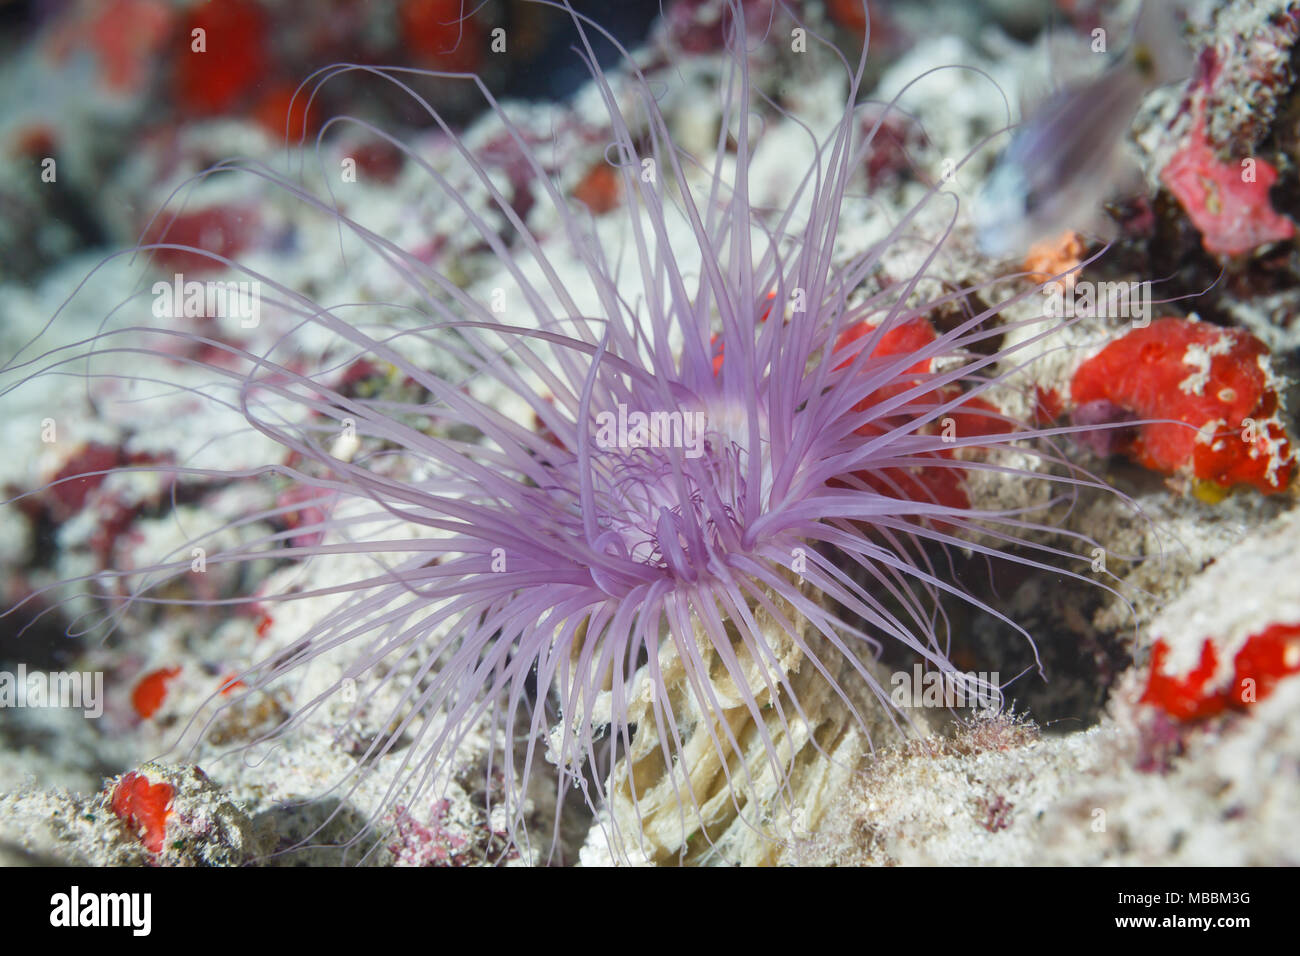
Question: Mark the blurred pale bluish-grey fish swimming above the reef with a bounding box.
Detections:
[974,0,1192,256]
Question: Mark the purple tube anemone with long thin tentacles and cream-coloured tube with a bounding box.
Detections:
[5,4,1128,860]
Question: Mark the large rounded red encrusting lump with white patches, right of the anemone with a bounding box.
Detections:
[1070,317,1295,494]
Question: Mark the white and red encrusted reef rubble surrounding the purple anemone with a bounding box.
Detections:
[0,0,1300,866]
